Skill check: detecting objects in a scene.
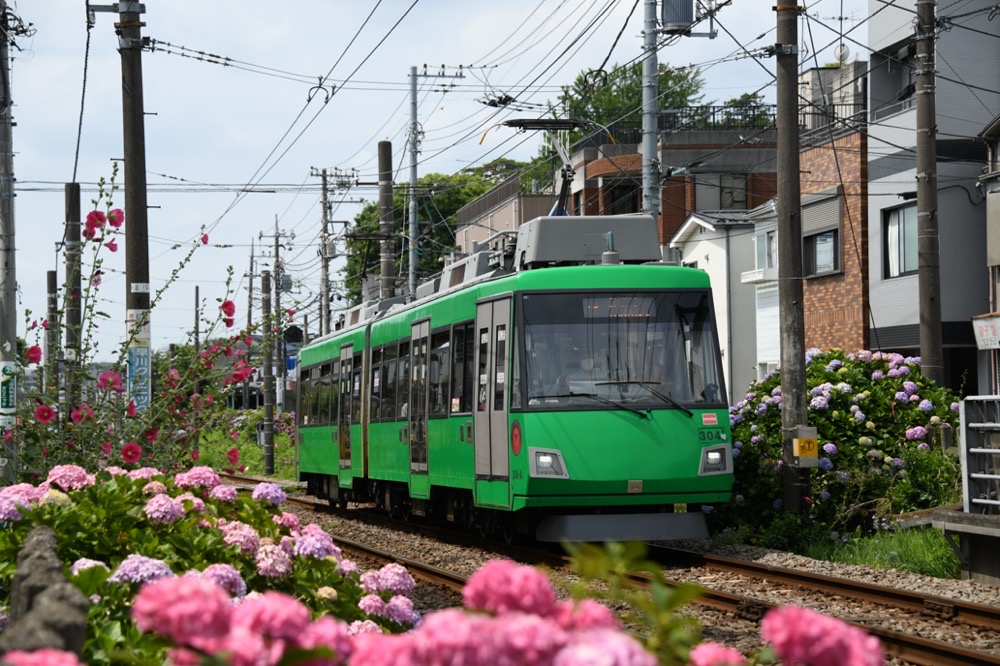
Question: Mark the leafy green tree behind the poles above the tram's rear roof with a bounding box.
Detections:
[343,165,525,305]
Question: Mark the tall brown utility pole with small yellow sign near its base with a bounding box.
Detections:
[775,4,815,513]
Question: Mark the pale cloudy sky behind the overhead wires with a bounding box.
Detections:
[8,0,867,360]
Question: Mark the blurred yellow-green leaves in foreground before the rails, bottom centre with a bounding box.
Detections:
[566,542,702,666]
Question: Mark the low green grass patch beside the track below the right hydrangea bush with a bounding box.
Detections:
[803,527,961,579]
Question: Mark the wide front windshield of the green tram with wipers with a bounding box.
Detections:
[521,290,724,409]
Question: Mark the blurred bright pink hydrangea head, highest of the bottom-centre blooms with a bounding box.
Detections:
[462,559,556,617]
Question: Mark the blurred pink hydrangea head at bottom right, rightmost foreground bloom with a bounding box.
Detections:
[760,606,885,666]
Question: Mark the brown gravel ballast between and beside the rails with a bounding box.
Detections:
[229,478,1000,666]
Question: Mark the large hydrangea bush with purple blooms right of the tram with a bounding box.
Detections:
[709,349,960,548]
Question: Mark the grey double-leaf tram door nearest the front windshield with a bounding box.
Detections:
[473,297,512,506]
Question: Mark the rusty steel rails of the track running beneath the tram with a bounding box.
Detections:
[223,477,1000,666]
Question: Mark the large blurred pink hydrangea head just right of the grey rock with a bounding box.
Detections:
[132,576,233,645]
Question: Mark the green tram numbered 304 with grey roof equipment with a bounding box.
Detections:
[298,216,733,541]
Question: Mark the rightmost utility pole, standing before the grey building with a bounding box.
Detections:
[915,0,944,384]
